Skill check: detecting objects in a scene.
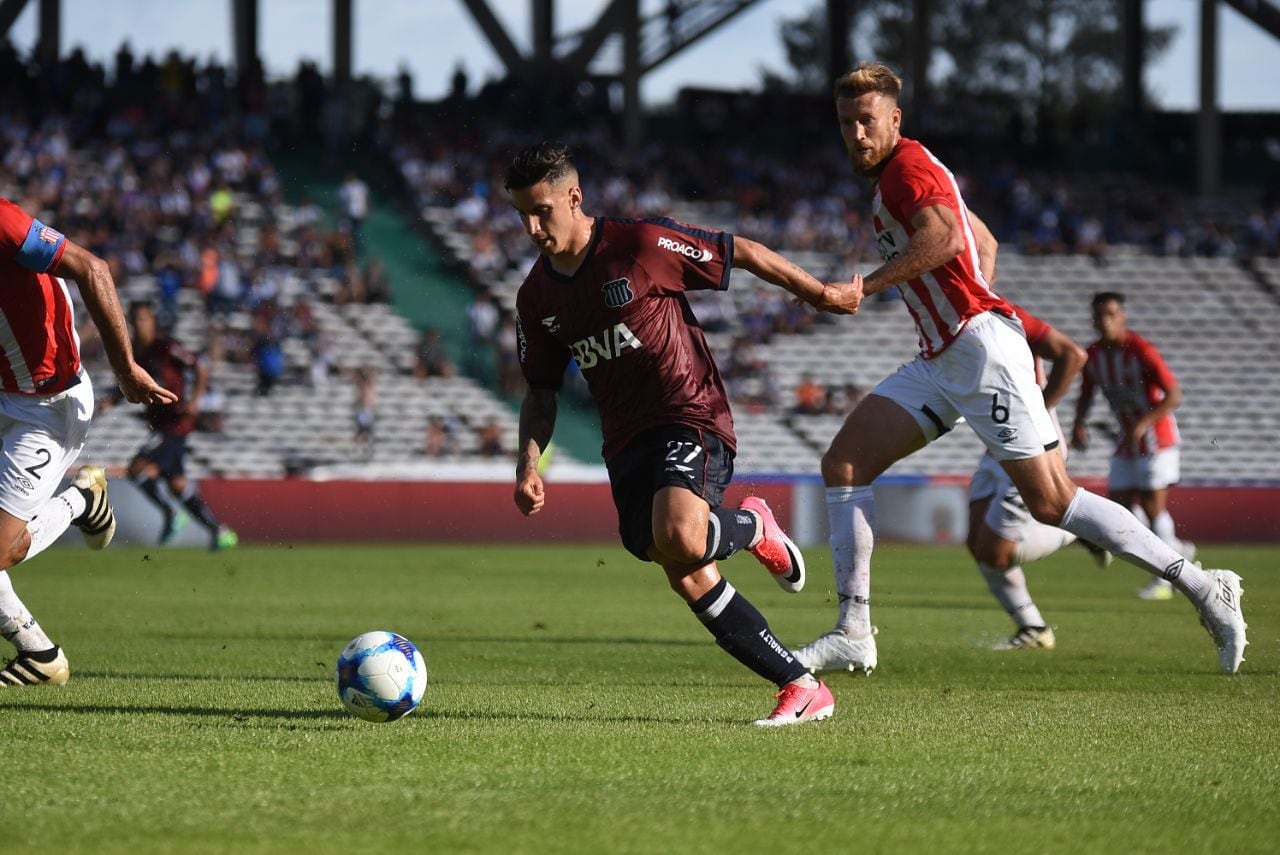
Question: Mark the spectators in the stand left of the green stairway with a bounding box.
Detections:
[0,42,404,428]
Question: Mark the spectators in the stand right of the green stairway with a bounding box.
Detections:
[379,85,1280,412]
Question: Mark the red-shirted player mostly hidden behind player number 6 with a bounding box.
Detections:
[966,305,1111,650]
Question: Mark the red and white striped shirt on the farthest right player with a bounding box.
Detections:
[1080,330,1179,457]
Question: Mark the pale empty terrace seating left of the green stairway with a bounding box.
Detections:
[81,202,517,477]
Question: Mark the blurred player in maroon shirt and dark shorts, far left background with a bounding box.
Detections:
[102,301,238,549]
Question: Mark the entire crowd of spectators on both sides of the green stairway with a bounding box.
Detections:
[0,42,1280,460]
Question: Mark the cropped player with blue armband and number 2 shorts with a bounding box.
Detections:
[0,198,177,687]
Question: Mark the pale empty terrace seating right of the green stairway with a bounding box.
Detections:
[422,204,1280,481]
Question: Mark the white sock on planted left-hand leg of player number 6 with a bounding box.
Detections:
[827,486,876,636]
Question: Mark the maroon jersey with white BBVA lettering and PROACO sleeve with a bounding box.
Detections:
[516,218,737,459]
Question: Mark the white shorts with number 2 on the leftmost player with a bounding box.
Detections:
[0,371,93,521]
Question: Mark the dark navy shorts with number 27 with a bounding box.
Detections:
[607,425,733,561]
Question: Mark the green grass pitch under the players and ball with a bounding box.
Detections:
[0,545,1280,854]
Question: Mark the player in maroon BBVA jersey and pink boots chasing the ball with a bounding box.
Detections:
[506,143,849,726]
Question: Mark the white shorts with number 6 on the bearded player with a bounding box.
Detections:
[872,312,1059,461]
